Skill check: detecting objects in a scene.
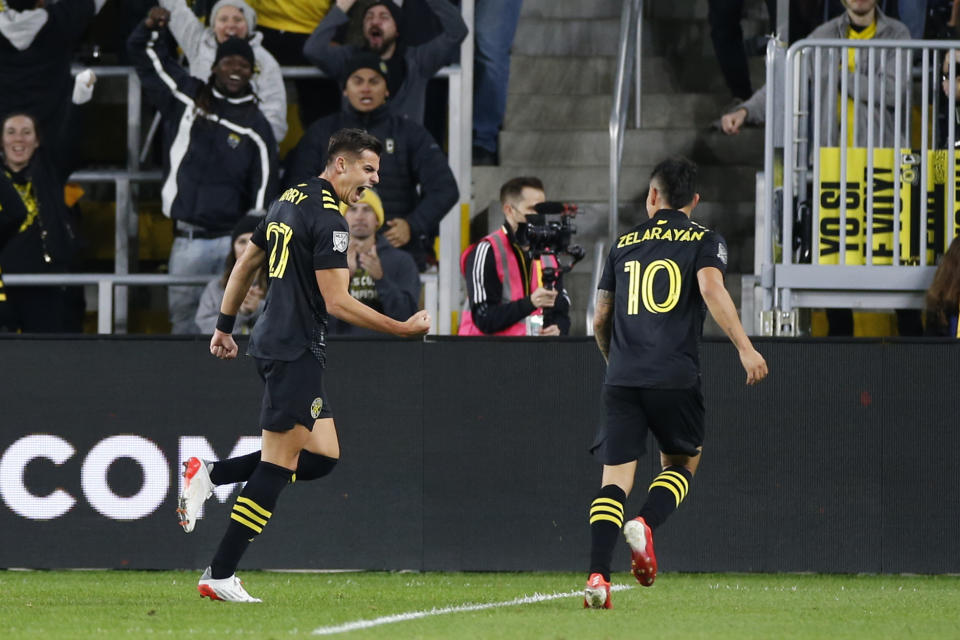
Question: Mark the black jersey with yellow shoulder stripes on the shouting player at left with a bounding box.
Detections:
[247,178,350,362]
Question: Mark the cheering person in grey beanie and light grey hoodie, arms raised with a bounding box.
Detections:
[159,0,287,143]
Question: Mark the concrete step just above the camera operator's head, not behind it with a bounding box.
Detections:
[500,128,763,167]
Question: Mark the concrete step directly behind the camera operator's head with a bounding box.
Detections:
[473,165,757,203]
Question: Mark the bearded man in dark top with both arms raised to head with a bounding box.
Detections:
[303,0,467,123]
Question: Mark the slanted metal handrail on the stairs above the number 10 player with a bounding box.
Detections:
[607,0,643,242]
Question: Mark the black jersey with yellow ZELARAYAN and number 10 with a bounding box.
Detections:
[598,209,727,389]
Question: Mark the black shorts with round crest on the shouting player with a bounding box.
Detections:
[254,351,333,431]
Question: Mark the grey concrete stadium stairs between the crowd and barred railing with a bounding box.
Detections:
[472,0,766,335]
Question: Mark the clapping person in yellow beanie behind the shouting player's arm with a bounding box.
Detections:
[327,189,420,337]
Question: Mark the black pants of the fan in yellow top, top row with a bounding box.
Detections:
[257,27,343,129]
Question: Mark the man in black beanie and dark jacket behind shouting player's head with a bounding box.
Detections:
[284,53,460,271]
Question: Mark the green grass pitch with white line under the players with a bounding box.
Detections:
[0,571,960,640]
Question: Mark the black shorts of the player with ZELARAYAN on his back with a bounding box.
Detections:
[590,385,704,465]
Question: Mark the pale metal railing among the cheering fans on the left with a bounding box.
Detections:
[4,5,474,334]
